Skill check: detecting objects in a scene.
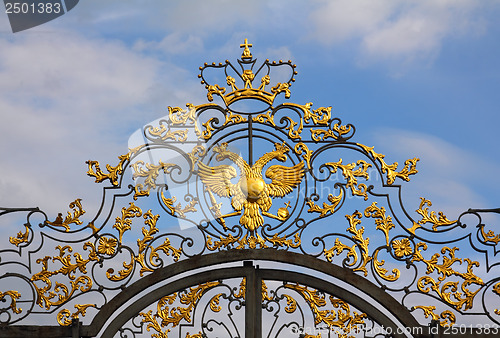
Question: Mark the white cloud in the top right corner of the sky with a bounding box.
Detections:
[310,0,483,62]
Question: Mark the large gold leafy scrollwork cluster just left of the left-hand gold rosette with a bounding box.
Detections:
[31,242,99,310]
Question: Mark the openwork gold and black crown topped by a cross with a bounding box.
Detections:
[198,39,297,107]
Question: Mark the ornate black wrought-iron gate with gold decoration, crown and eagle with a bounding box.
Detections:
[0,40,500,338]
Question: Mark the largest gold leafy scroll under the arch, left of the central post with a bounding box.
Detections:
[139,282,220,338]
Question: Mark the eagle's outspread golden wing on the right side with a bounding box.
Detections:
[266,162,304,197]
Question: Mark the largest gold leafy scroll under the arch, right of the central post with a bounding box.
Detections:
[285,283,367,335]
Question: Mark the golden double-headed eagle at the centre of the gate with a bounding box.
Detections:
[198,143,304,231]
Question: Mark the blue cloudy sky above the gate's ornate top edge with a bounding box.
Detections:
[0,0,500,226]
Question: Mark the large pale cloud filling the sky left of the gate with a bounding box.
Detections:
[0,32,163,213]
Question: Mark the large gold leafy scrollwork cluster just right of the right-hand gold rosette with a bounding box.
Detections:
[412,243,484,310]
